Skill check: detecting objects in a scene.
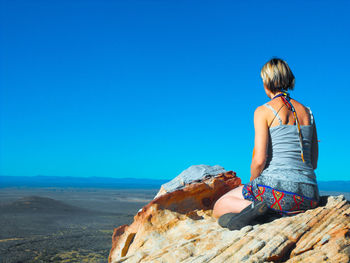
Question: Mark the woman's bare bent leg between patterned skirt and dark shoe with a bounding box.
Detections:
[213,185,252,218]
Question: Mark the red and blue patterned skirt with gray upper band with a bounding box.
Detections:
[242,177,319,216]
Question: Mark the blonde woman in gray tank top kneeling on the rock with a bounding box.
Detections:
[213,58,319,230]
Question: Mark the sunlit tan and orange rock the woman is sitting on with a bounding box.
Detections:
[109,166,350,263]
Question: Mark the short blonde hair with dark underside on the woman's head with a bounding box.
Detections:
[260,58,295,92]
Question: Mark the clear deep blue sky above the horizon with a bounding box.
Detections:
[0,0,350,181]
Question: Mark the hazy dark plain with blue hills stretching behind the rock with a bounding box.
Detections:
[0,177,350,263]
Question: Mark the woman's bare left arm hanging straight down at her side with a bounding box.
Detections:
[250,106,269,181]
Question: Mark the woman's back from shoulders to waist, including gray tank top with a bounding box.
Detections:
[261,99,316,184]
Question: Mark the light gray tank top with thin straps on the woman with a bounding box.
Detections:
[260,103,317,185]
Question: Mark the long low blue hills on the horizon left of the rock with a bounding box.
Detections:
[0,175,168,189]
